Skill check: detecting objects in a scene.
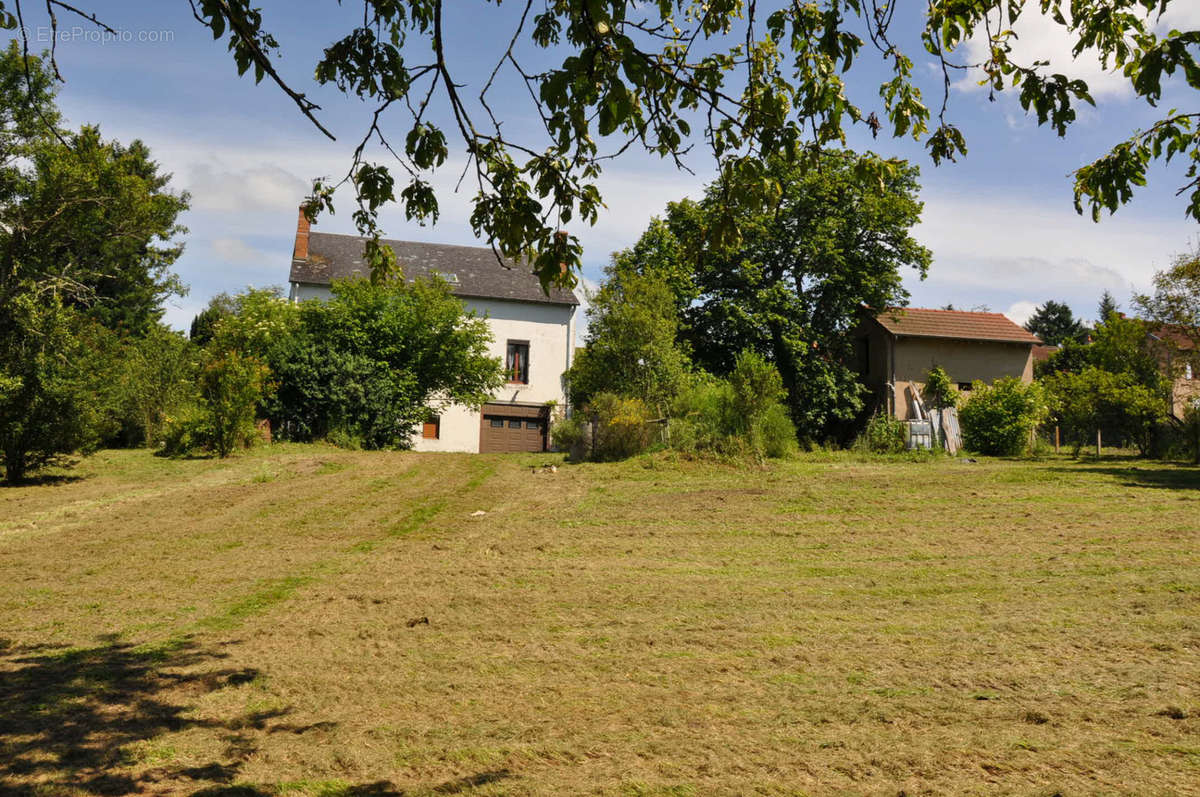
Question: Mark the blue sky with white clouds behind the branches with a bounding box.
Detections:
[18,0,1200,329]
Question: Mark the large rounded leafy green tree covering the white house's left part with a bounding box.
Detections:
[265,280,504,448]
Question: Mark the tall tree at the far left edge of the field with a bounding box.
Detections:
[0,44,186,481]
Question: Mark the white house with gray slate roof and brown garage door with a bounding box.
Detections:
[289,211,580,453]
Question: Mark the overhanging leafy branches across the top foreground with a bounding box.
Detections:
[0,0,1200,292]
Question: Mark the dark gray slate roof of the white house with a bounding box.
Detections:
[290,232,580,305]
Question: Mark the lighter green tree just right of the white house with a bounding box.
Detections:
[566,266,689,414]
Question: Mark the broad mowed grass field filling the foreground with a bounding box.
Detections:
[0,445,1200,795]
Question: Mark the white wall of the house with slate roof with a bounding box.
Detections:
[290,283,576,453]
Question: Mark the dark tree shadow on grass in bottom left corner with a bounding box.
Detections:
[0,637,386,795]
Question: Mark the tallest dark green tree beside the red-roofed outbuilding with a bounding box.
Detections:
[667,151,930,439]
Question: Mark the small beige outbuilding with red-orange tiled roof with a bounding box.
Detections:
[852,307,1042,420]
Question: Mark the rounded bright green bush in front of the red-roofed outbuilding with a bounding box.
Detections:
[959,377,1046,456]
